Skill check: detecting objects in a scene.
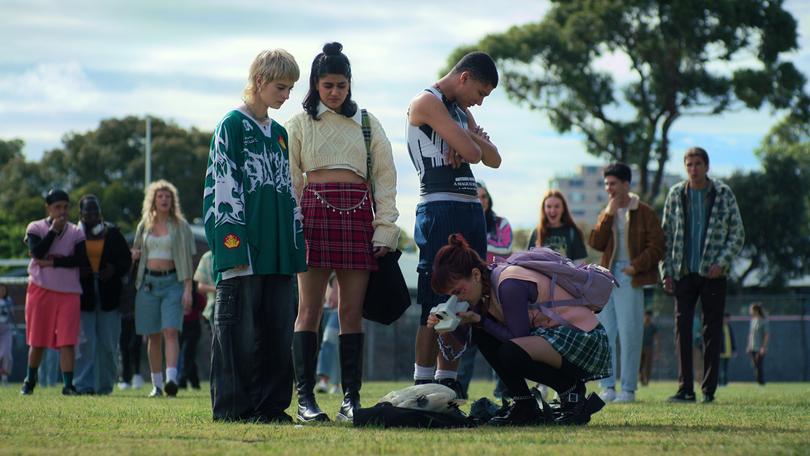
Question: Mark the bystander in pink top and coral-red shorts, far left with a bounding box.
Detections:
[20,189,87,396]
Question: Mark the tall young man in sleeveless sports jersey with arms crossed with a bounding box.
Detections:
[407,52,501,398]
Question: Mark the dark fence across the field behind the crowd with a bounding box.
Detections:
[0,277,810,381]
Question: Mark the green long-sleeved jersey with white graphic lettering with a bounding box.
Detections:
[203,110,306,280]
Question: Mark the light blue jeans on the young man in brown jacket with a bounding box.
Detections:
[597,261,644,393]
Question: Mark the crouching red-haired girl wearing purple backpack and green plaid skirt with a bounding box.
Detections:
[427,234,613,426]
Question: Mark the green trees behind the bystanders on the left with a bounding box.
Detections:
[0,116,211,257]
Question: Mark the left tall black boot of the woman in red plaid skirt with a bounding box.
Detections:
[293,331,329,423]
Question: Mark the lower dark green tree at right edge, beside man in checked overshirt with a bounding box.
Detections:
[727,120,810,288]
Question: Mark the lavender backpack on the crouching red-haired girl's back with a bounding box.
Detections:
[490,247,619,326]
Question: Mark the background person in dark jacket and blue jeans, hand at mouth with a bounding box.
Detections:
[74,195,132,394]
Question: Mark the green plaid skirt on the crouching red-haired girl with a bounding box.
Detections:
[531,323,612,381]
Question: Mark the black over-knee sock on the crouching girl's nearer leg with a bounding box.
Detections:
[498,341,584,397]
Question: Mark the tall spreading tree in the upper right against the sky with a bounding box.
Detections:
[449,0,810,201]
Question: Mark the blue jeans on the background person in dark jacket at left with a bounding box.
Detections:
[73,306,121,394]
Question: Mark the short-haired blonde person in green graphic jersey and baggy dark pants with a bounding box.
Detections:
[203,49,306,423]
